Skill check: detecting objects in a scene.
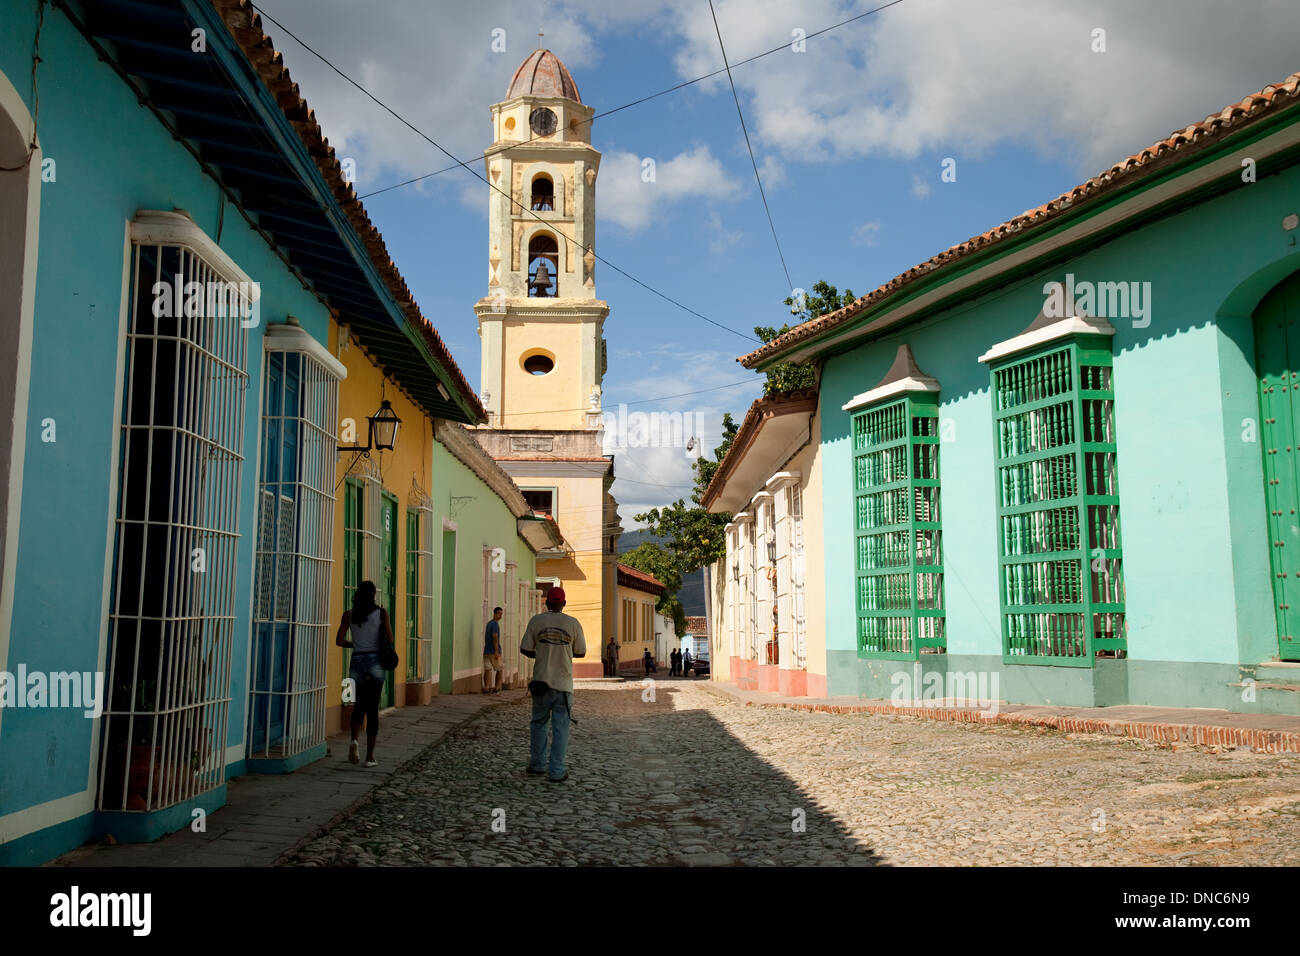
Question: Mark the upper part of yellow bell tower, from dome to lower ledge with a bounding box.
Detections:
[475,49,608,431]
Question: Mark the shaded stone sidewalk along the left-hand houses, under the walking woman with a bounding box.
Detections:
[46,689,528,866]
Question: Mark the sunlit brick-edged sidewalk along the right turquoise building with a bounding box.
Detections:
[701,680,1300,753]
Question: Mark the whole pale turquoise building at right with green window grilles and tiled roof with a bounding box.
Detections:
[741,74,1300,714]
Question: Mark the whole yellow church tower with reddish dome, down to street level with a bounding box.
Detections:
[475,49,623,676]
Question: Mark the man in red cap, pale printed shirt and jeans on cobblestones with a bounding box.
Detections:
[519,588,586,783]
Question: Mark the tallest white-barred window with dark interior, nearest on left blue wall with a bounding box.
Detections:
[96,235,251,812]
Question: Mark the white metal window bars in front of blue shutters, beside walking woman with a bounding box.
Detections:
[248,351,338,757]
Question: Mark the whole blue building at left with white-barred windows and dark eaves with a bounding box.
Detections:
[0,0,488,865]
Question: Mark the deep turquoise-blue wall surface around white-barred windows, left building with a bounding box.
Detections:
[0,0,329,832]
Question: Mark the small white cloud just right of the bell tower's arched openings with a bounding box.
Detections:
[597,146,740,232]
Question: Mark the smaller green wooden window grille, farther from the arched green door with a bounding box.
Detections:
[853,392,945,661]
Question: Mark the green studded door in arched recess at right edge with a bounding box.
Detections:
[1255,265,1300,661]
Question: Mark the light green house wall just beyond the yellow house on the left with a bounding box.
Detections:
[432,441,537,679]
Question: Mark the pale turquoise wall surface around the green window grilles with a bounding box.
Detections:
[822,158,1300,706]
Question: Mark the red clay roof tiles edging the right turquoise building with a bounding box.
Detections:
[737,73,1300,368]
